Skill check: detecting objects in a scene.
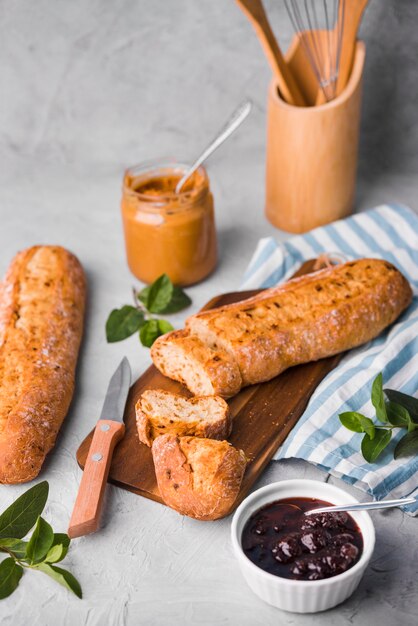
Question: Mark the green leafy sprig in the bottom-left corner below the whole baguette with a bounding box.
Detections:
[0,481,82,600]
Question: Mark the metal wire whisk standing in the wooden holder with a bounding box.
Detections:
[284,0,346,102]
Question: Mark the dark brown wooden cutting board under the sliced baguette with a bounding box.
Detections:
[77,261,342,512]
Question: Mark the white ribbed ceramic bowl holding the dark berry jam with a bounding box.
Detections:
[231,480,375,613]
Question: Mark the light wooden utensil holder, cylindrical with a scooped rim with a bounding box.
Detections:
[265,41,366,233]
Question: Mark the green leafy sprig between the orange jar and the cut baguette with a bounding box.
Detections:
[106,274,192,348]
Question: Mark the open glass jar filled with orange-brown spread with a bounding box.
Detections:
[122,161,217,286]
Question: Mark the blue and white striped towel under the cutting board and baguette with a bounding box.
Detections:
[241,205,418,515]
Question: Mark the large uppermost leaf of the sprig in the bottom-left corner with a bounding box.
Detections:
[0,481,49,539]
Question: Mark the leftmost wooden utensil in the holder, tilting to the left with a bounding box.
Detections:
[237,0,306,106]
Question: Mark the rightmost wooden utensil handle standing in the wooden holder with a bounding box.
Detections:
[336,0,368,96]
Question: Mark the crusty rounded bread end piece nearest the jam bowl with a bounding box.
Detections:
[152,435,247,520]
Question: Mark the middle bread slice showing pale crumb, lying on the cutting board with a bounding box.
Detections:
[135,389,232,446]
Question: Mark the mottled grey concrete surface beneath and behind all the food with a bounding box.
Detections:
[0,0,418,626]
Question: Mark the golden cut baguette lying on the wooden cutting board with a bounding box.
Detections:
[151,259,412,397]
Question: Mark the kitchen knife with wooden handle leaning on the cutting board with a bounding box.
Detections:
[68,357,131,539]
